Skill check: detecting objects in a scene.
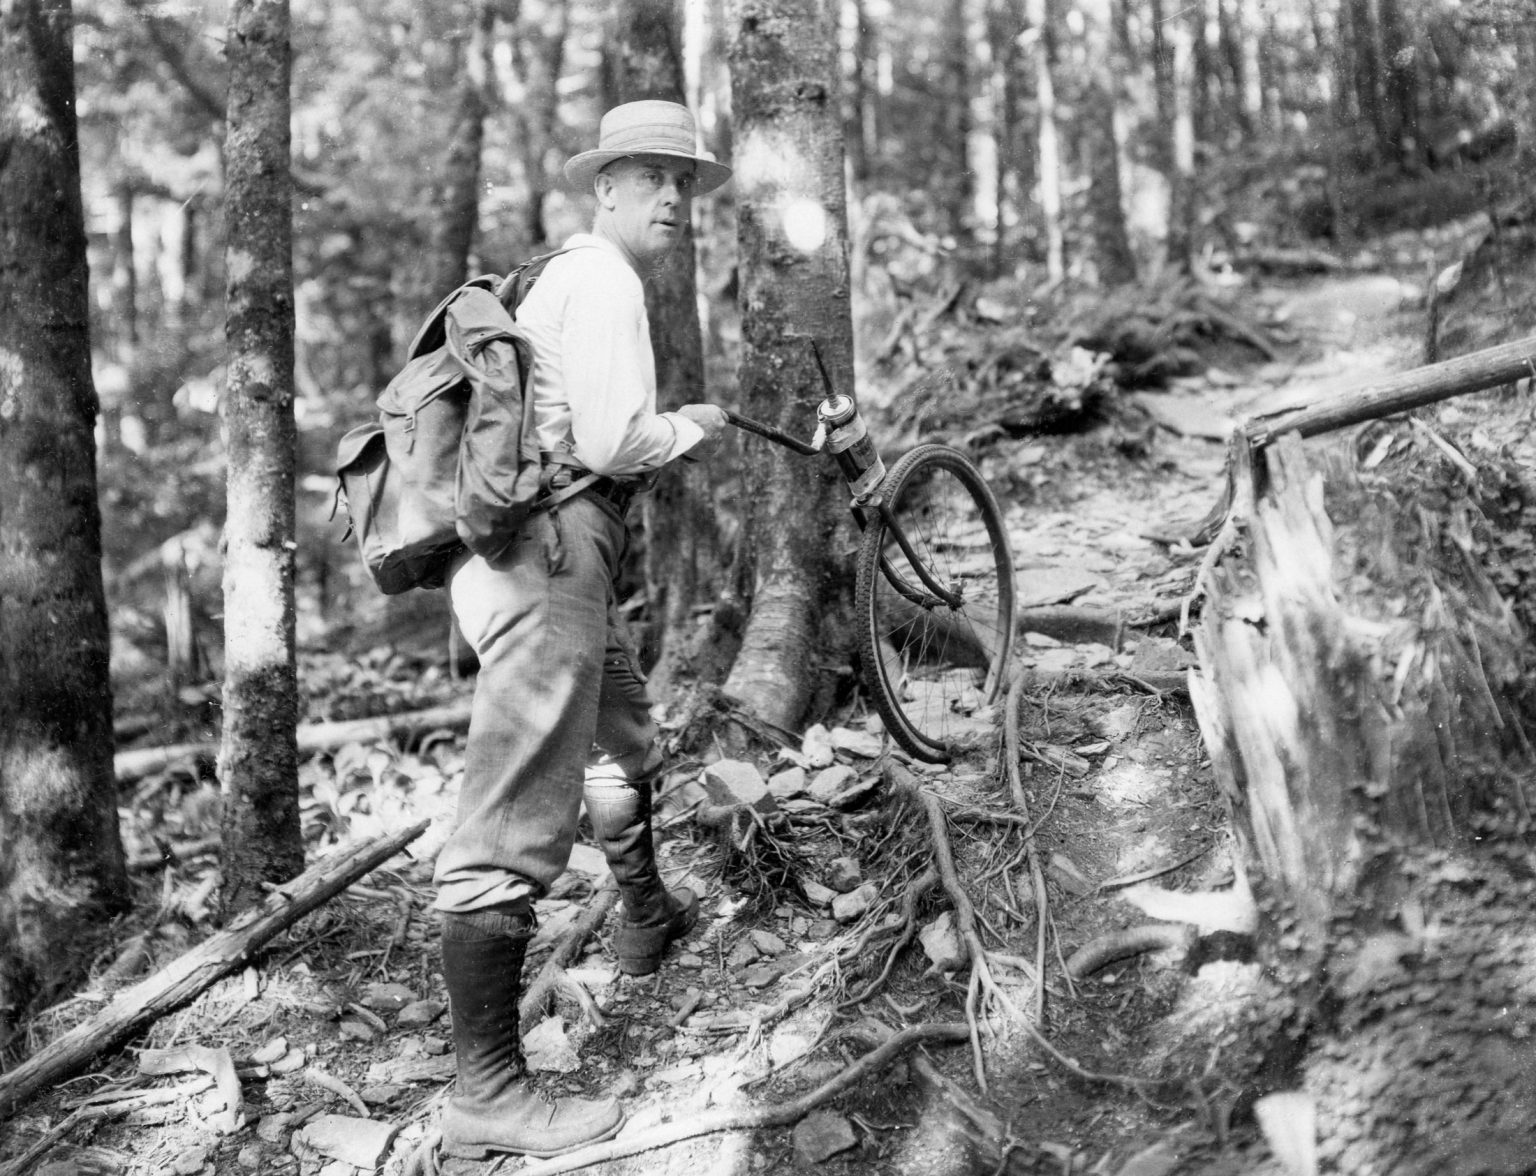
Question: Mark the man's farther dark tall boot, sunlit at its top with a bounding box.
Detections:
[582,769,699,976]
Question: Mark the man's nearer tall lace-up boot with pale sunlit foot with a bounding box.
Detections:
[442,903,624,1159]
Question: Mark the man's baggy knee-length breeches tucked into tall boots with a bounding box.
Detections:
[436,494,656,912]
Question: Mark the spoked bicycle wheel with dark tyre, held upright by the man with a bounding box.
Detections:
[856,445,1014,763]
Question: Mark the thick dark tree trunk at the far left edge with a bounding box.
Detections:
[0,0,129,1029]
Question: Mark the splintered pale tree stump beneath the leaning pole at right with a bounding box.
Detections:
[1192,427,1533,932]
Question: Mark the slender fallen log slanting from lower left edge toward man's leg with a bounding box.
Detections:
[0,821,429,1122]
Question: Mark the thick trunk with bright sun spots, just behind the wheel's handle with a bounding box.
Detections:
[725,0,852,728]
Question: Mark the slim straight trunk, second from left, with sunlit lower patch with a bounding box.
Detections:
[218,0,304,913]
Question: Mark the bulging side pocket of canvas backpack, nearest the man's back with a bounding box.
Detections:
[445,285,539,559]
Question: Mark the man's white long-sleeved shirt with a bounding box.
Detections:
[518,233,703,477]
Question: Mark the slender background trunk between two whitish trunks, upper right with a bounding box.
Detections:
[1078,0,1137,287]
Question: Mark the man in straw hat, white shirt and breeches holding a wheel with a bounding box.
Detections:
[436,101,731,1159]
